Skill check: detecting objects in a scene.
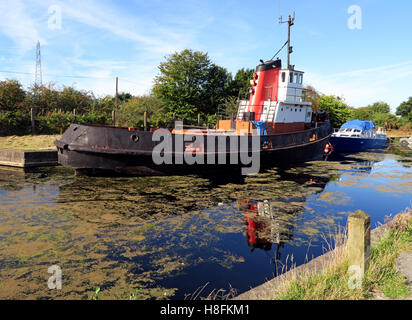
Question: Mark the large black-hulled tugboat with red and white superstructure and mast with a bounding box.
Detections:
[55,16,333,175]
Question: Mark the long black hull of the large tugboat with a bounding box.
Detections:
[55,122,333,175]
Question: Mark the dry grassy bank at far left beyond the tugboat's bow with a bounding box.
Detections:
[0,134,61,150]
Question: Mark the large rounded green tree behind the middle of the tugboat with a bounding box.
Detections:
[153,49,231,119]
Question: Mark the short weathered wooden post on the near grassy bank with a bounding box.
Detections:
[348,210,371,277]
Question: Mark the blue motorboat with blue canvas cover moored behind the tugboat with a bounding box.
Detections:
[329,120,387,153]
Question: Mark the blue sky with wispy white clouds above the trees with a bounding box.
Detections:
[0,0,412,111]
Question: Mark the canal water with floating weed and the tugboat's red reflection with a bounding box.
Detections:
[0,152,412,299]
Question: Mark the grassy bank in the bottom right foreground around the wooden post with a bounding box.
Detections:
[274,209,412,300]
